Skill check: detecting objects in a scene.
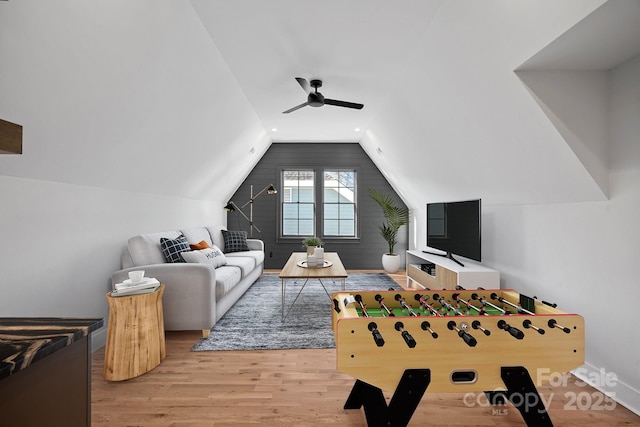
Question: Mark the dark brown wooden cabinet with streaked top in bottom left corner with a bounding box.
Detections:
[0,318,104,427]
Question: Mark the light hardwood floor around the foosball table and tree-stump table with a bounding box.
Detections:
[91,271,640,427]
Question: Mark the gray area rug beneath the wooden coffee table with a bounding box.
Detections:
[191,273,401,351]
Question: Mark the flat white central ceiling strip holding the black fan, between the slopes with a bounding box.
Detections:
[192,0,442,141]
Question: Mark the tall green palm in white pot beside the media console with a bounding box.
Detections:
[367,188,409,273]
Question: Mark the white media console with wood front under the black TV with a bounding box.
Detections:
[406,250,500,290]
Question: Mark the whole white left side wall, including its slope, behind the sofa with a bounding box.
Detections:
[0,0,269,352]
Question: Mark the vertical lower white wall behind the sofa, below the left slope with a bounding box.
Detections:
[0,176,226,348]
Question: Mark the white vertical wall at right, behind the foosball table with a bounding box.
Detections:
[483,58,640,413]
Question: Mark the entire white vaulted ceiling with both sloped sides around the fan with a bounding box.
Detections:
[0,0,640,207]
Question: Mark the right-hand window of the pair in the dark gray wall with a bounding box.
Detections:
[322,170,356,237]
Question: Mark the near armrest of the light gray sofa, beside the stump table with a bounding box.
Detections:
[111,263,216,331]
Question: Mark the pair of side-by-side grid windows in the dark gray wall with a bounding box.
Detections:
[280,169,358,239]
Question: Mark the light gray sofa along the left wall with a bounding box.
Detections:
[111,226,264,336]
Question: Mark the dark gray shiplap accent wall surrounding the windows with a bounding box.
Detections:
[227,143,408,270]
